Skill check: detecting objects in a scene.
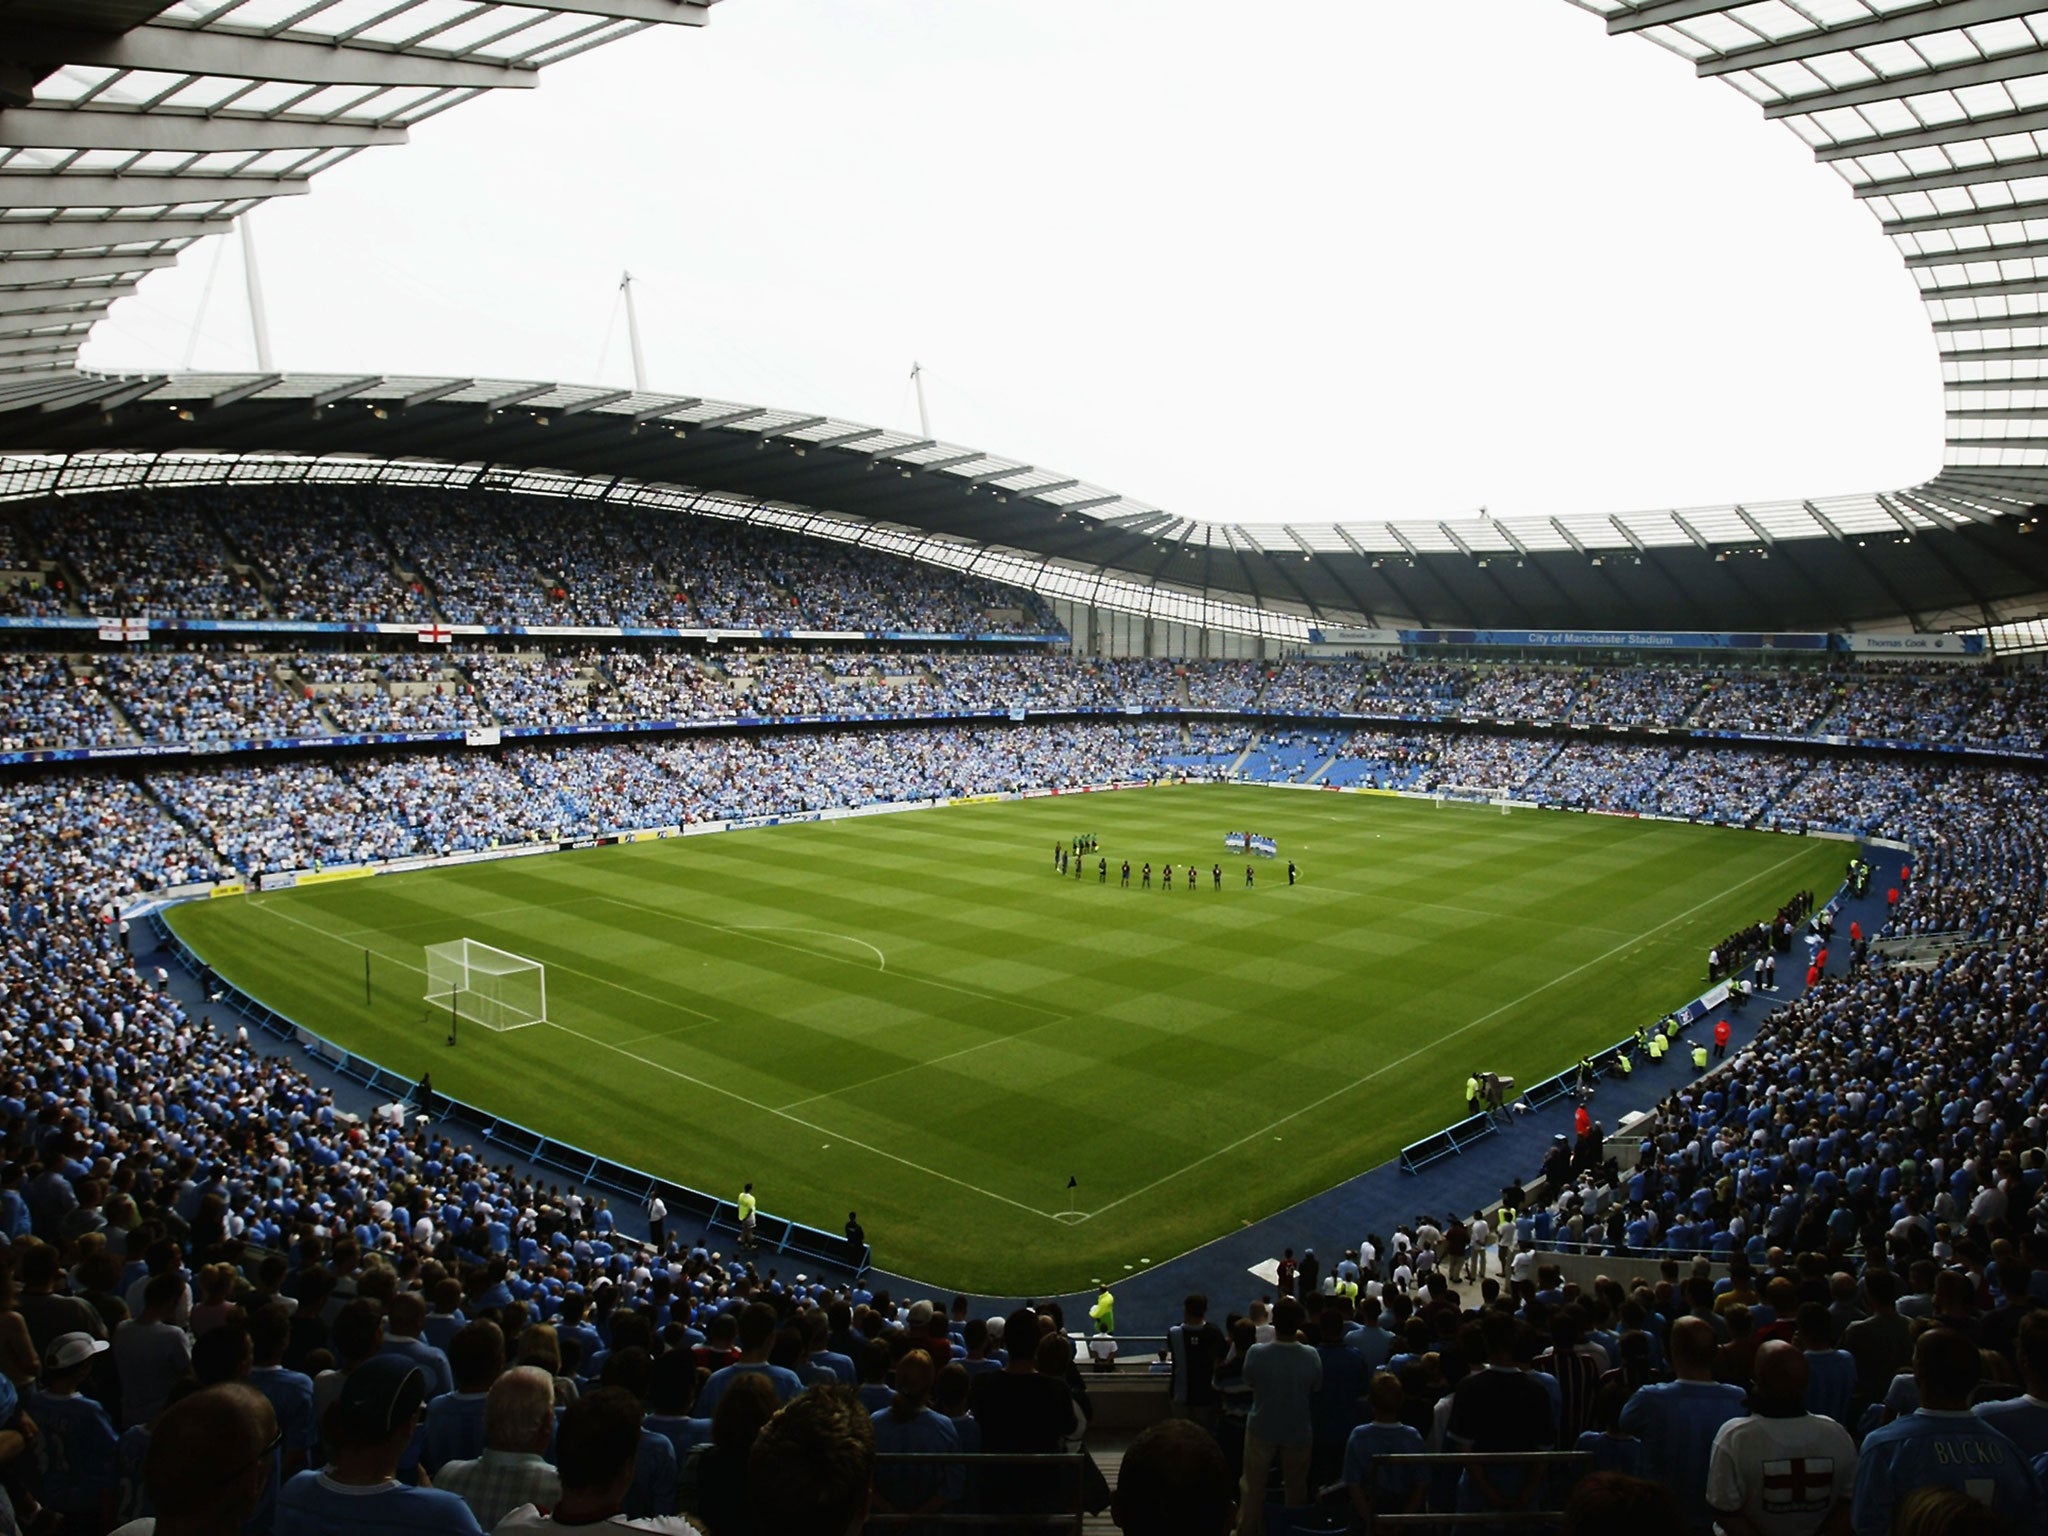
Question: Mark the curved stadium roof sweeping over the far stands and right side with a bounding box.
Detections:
[0,0,2048,633]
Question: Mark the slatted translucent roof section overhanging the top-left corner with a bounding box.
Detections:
[0,0,717,375]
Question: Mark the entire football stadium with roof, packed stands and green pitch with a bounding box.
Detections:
[0,0,2048,1536]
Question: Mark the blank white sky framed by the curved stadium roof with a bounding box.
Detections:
[84,0,1942,522]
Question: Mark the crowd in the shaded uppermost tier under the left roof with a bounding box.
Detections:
[0,485,1059,635]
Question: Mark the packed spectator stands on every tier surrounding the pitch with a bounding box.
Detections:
[0,492,2048,1530]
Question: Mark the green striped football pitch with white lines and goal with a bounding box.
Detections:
[170,784,1845,1294]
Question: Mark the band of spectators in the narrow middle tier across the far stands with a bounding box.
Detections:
[0,635,2048,765]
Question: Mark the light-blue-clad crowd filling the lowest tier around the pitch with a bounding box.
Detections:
[0,679,2048,1536]
